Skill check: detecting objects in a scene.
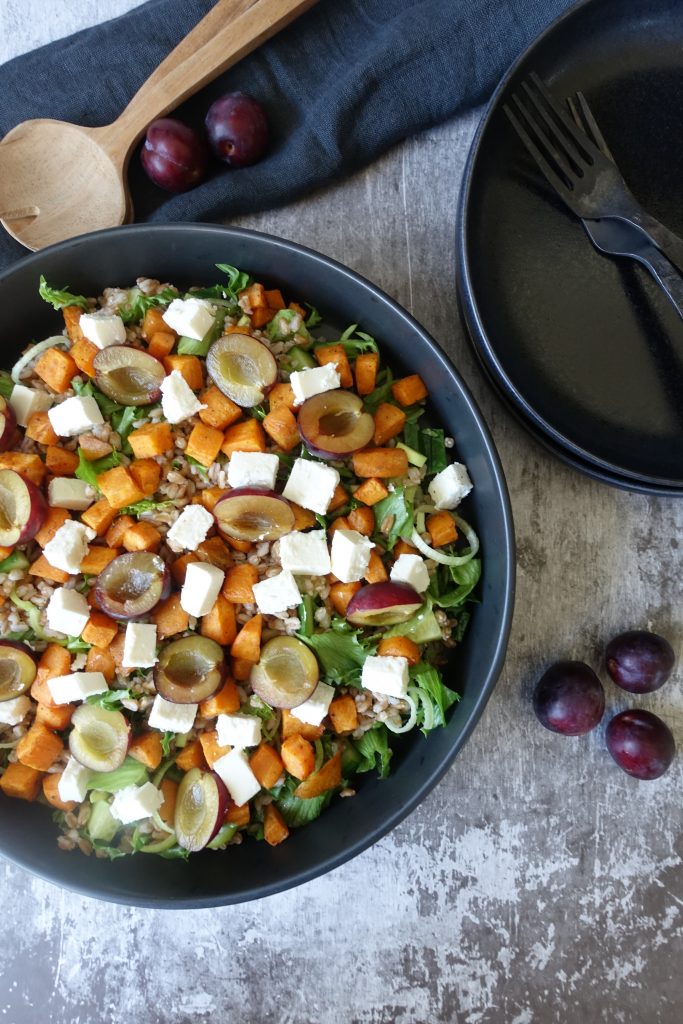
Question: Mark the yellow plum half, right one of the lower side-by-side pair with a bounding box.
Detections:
[249,637,321,708]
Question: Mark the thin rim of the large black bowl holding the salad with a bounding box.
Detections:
[0,222,516,910]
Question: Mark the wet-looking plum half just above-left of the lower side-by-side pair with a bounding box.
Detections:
[95,551,171,622]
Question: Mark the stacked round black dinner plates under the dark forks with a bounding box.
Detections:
[458,0,683,494]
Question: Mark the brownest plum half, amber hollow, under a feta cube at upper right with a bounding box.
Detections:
[299,388,375,459]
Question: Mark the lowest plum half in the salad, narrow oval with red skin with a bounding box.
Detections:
[173,768,230,853]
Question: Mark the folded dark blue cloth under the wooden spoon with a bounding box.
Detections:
[0,0,572,267]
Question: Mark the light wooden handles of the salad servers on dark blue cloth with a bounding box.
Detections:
[102,0,316,157]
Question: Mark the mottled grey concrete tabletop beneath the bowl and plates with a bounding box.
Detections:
[0,0,683,1024]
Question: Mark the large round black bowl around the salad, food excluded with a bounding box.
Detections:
[0,224,514,908]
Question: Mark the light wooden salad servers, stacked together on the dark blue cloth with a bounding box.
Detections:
[0,0,315,250]
